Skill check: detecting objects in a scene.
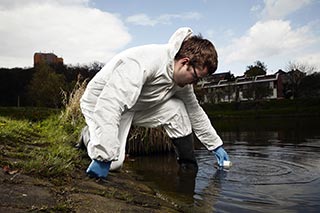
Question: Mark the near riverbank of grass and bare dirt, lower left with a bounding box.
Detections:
[0,110,181,212]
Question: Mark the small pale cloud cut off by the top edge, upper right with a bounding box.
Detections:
[262,0,312,20]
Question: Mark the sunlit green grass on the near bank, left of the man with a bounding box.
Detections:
[0,109,87,177]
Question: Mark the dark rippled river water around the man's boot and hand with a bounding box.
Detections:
[130,117,320,212]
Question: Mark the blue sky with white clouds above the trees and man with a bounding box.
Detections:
[0,0,320,76]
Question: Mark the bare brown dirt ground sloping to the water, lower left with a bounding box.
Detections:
[0,168,179,213]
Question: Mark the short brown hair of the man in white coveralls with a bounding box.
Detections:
[174,35,218,75]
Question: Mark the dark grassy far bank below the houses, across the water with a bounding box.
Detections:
[203,99,320,119]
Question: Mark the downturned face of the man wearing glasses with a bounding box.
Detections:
[173,58,208,87]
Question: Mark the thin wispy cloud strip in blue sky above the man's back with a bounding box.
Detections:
[126,12,201,26]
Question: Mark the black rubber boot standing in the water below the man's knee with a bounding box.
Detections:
[172,134,198,172]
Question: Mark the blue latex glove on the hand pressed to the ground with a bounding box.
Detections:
[86,160,111,178]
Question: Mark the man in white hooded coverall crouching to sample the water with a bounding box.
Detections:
[80,28,229,178]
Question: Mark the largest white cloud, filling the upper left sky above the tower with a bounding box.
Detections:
[0,0,131,67]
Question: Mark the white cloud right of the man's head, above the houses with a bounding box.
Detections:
[221,20,317,63]
